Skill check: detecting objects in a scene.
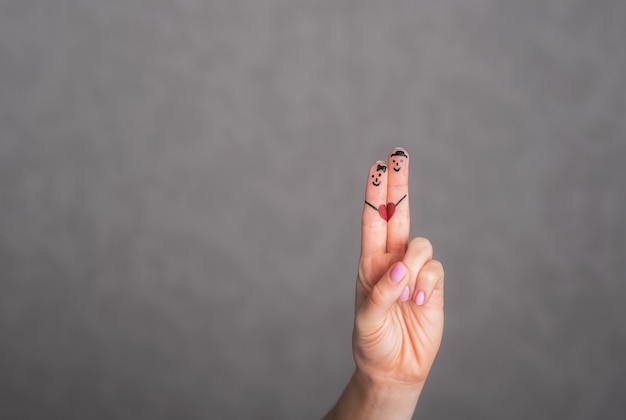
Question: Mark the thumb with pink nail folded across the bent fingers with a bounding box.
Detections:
[361,261,410,329]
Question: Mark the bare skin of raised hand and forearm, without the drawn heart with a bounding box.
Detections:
[325,148,444,419]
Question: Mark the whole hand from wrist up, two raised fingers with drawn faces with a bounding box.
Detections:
[353,149,444,387]
